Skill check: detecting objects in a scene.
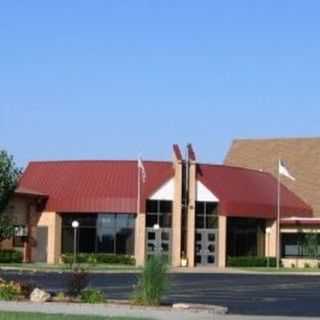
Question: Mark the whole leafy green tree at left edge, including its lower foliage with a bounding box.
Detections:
[0,150,21,242]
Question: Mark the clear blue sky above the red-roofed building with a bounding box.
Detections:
[0,0,320,166]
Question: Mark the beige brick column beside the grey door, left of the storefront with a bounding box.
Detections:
[38,212,62,264]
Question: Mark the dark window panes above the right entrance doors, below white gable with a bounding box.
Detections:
[196,201,218,229]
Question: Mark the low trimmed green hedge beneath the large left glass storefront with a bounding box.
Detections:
[61,253,136,266]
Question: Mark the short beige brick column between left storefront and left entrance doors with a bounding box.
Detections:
[134,212,146,267]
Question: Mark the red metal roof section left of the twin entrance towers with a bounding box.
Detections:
[17,161,174,213]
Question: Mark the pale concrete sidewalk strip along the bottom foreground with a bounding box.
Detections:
[0,302,318,320]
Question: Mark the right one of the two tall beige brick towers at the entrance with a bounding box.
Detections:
[187,161,197,267]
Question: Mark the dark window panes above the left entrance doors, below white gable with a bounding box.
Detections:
[146,200,172,228]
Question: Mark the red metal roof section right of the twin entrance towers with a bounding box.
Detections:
[197,164,312,218]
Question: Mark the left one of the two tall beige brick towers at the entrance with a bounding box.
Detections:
[172,153,182,267]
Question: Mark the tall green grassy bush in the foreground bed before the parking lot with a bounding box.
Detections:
[134,257,168,305]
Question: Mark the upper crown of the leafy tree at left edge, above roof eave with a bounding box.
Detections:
[0,150,21,213]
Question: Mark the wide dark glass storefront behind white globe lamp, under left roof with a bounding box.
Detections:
[62,213,135,255]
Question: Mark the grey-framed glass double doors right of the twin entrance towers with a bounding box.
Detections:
[196,229,218,266]
